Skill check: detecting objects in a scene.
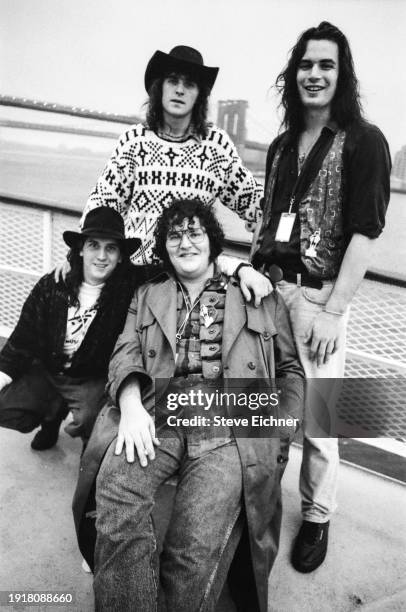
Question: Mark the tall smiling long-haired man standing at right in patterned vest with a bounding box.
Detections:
[253,22,391,572]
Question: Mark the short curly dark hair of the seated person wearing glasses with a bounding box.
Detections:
[154,199,224,269]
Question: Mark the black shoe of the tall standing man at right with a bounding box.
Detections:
[291,521,330,574]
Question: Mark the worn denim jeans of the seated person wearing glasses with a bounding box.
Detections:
[94,433,242,612]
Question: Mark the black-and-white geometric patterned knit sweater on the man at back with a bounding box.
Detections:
[83,124,262,264]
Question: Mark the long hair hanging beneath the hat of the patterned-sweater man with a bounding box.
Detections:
[146,73,210,138]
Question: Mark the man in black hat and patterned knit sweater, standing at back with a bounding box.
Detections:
[80,46,271,299]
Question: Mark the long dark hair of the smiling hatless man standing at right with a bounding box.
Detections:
[275,21,363,135]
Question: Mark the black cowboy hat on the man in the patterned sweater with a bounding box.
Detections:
[144,45,219,93]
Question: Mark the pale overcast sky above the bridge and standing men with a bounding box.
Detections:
[0,0,406,153]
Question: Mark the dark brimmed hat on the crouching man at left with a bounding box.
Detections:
[62,206,141,255]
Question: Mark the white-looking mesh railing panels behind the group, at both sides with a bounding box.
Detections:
[0,194,406,464]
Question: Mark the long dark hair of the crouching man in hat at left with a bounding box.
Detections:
[65,238,133,308]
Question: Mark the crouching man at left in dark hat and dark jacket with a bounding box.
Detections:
[0,206,142,450]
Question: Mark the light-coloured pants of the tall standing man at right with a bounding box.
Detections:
[278,281,348,523]
